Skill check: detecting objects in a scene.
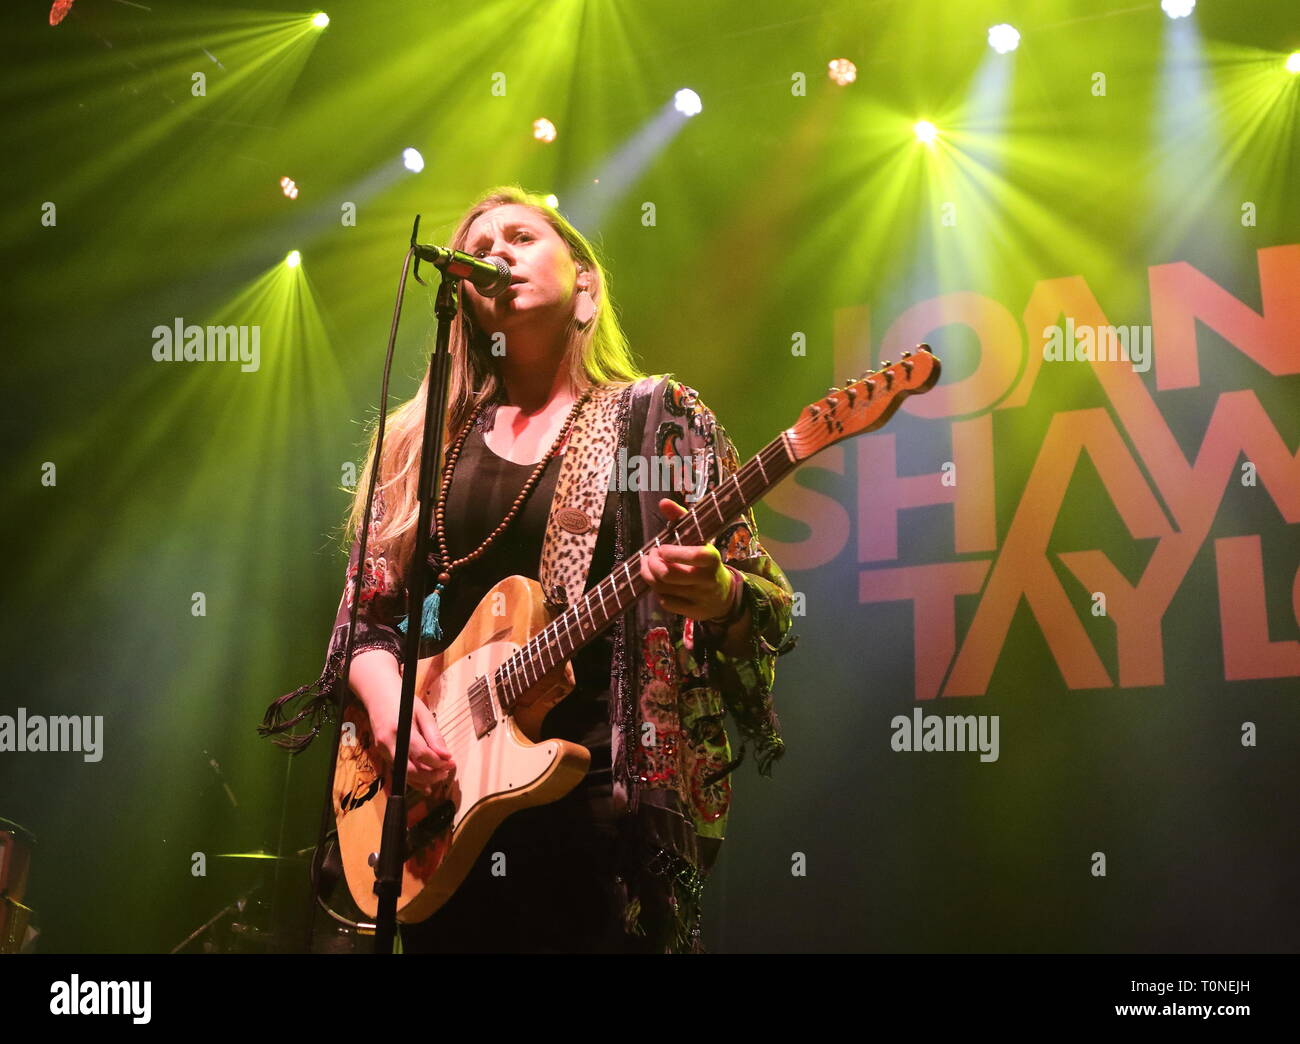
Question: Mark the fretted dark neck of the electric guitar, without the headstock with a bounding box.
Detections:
[497,432,800,705]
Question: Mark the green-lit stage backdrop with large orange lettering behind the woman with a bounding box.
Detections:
[0,0,1300,952]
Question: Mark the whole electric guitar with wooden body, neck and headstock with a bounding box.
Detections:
[333,345,940,923]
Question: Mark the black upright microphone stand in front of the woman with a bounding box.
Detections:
[374,217,460,953]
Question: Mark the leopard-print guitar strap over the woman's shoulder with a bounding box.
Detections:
[537,387,632,608]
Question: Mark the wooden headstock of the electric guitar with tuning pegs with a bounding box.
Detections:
[787,345,940,460]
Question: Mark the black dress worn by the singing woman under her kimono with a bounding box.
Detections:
[402,410,646,953]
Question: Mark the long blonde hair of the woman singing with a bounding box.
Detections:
[343,185,646,577]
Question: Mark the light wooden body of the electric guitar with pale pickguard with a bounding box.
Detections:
[333,576,592,924]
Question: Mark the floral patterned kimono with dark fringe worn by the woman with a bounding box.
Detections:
[260,374,794,952]
